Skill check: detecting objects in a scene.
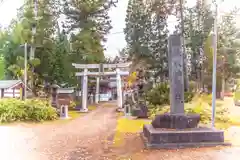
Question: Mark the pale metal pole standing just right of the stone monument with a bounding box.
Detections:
[212,1,218,128]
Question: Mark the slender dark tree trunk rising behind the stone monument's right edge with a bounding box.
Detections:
[180,0,188,91]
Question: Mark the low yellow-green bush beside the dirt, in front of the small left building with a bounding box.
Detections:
[0,99,57,123]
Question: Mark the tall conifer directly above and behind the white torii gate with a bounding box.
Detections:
[64,0,115,63]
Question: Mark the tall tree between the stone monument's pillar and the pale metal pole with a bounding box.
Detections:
[178,0,213,86]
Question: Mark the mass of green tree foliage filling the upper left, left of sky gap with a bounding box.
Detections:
[0,0,115,93]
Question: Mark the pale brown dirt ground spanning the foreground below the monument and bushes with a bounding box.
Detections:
[0,100,240,160]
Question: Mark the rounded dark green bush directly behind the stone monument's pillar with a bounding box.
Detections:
[146,83,194,105]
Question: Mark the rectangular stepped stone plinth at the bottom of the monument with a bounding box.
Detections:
[141,124,231,149]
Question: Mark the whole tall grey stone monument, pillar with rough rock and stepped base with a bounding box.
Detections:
[142,34,228,148]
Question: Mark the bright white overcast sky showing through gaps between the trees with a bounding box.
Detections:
[0,0,240,57]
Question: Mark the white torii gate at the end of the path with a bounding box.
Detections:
[72,62,131,112]
